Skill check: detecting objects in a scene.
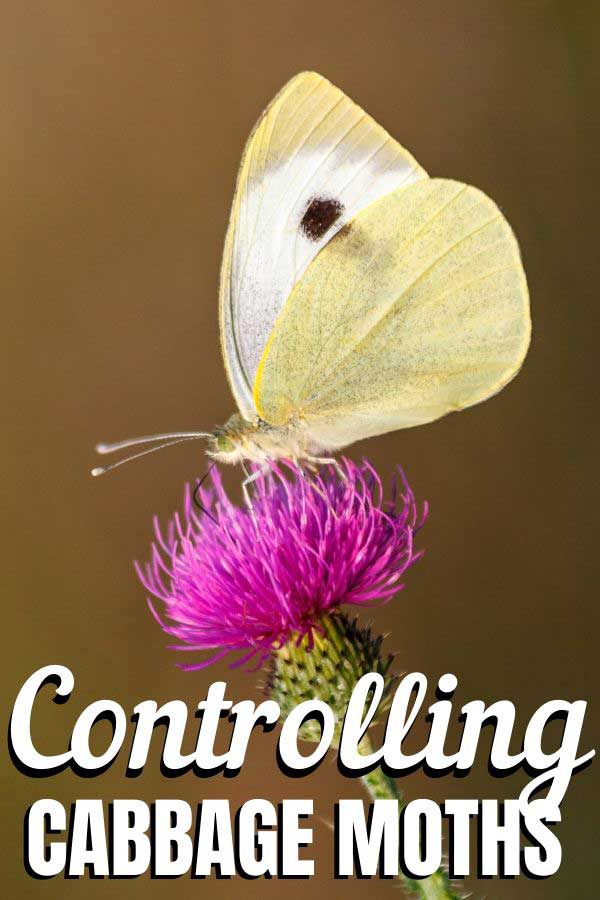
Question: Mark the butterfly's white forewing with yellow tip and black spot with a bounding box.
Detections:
[220,72,427,419]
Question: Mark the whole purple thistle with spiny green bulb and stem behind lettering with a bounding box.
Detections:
[136,459,459,900]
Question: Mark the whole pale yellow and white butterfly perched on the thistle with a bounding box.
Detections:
[93,72,531,496]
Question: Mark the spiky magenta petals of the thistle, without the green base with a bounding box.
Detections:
[136,459,427,670]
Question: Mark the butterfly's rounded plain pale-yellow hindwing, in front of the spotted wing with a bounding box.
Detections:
[254,179,530,449]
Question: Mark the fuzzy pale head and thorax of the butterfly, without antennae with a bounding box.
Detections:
[207,413,317,464]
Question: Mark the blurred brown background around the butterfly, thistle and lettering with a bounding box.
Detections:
[0,0,600,900]
